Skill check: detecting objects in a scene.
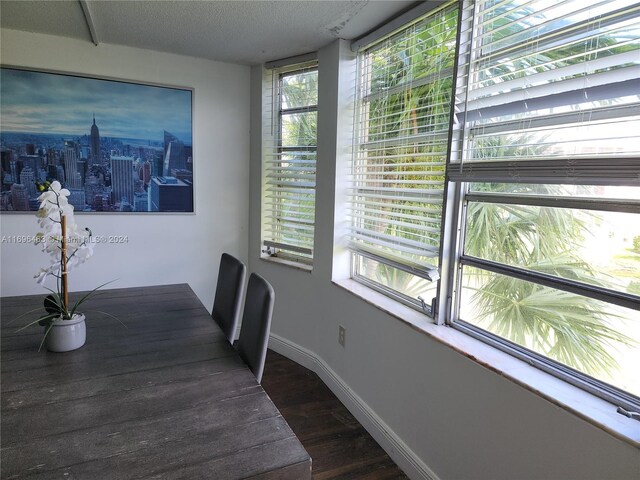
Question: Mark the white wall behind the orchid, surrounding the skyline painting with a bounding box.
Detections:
[0,29,249,309]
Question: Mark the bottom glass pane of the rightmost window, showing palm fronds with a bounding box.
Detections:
[460,267,640,396]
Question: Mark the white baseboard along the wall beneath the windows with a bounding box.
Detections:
[269,334,439,480]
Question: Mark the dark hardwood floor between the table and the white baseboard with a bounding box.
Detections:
[262,350,408,480]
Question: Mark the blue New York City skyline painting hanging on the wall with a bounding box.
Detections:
[0,67,193,212]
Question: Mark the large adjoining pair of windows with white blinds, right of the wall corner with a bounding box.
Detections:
[352,0,640,414]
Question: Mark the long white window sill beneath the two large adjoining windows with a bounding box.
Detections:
[333,279,640,448]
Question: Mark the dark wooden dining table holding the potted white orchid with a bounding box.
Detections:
[0,284,311,480]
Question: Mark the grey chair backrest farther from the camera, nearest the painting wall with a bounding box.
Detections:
[211,253,247,343]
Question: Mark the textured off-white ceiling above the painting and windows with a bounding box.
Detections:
[0,0,415,64]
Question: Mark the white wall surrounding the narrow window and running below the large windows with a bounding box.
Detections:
[249,41,640,480]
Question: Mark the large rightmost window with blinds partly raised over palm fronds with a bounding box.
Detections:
[451,0,640,408]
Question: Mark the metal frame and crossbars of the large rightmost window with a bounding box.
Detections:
[440,2,640,411]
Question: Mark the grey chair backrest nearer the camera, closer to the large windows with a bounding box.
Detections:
[236,273,275,383]
